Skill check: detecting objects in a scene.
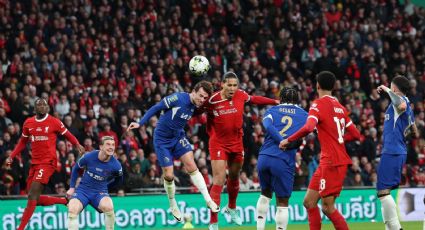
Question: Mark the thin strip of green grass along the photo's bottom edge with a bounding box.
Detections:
[169,221,423,230]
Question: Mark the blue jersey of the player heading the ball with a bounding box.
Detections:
[139,93,196,138]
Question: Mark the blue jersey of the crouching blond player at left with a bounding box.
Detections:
[70,150,123,193]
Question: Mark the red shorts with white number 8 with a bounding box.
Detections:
[308,165,347,197]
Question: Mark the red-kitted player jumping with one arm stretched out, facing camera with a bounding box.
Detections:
[204,72,279,229]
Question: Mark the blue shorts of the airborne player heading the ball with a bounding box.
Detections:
[153,133,193,167]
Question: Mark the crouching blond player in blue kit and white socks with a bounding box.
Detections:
[67,136,123,230]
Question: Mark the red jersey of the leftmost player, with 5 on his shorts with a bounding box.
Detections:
[22,114,68,166]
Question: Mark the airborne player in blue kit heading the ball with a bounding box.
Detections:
[127,81,220,222]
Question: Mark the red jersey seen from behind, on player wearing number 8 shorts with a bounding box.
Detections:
[308,96,353,165]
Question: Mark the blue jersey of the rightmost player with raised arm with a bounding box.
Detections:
[382,97,415,154]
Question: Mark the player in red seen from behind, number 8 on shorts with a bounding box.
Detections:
[279,71,360,230]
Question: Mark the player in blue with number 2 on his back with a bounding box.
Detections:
[253,88,308,230]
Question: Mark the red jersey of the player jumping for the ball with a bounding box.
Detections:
[205,89,277,152]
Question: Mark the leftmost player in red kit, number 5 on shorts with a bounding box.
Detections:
[7,98,84,230]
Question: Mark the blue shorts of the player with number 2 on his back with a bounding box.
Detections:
[257,155,295,198]
